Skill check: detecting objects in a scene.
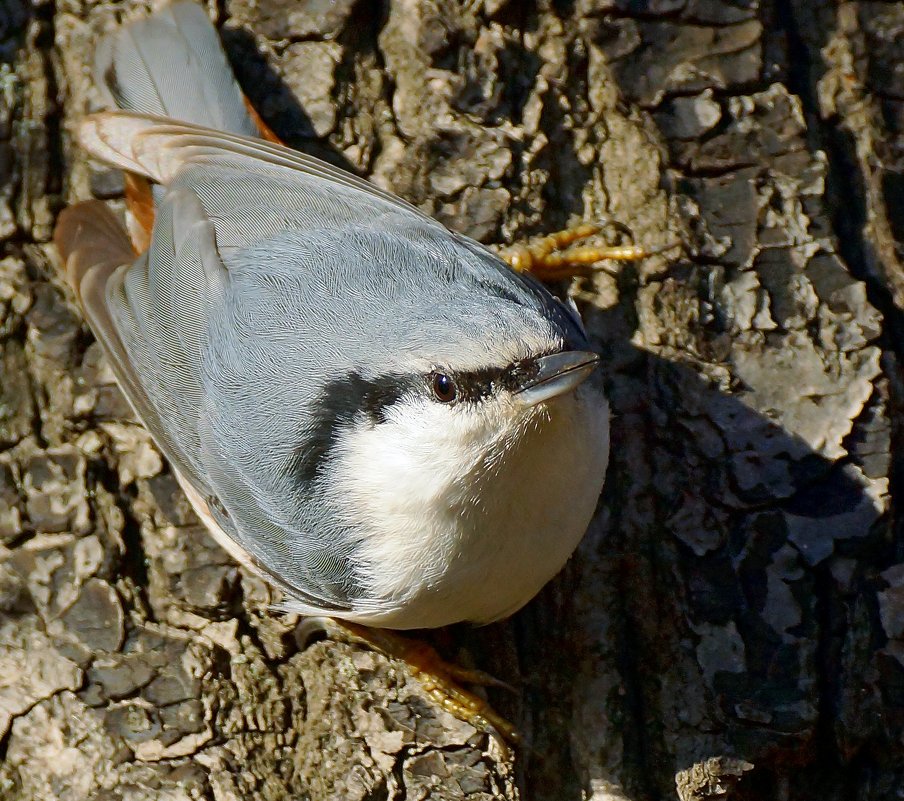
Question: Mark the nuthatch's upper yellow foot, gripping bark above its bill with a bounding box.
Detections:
[499,220,680,281]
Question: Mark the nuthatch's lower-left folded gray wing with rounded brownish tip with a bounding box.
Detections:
[55,197,360,614]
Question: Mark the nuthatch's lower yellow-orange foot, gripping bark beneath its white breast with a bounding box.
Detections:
[296,617,521,745]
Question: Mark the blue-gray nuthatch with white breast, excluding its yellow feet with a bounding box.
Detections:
[56,3,609,629]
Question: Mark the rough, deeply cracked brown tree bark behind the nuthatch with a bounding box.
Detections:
[0,0,904,801]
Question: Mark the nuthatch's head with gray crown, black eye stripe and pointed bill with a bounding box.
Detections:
[282,231,607,506]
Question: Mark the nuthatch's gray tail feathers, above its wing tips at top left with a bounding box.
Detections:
[94,2,259,136]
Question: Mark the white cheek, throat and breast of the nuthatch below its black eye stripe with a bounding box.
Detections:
[324,384,609,629]
